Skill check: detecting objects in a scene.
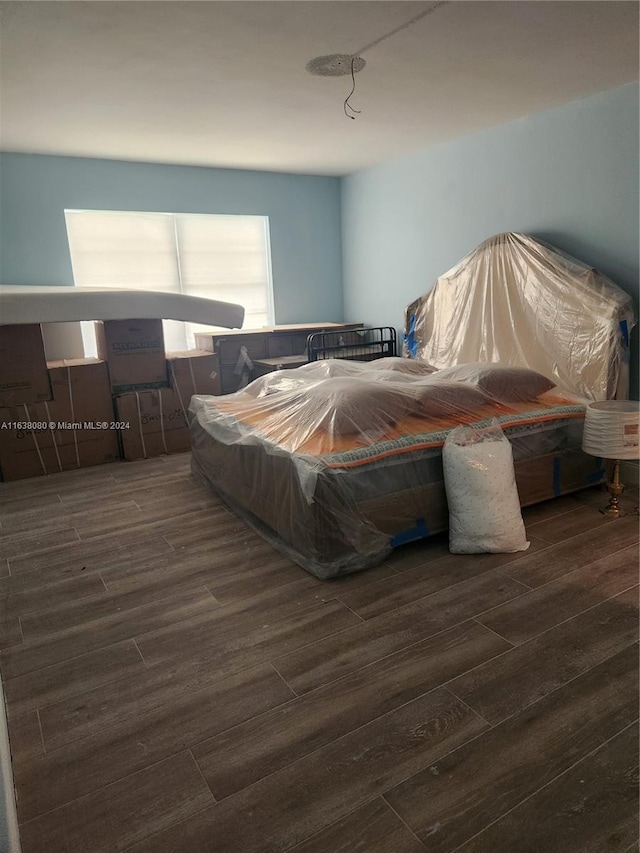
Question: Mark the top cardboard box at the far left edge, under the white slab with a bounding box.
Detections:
[0,323,51,406]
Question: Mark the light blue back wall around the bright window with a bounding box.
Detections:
[0,154,342,323]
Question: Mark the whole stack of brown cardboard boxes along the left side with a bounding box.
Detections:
[0,320,220,480]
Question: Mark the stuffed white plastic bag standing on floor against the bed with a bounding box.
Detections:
[442,423,529,554]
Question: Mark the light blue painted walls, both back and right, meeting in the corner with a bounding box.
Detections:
[0,83,639,393]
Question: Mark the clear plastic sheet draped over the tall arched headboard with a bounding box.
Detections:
[404,233,636,400]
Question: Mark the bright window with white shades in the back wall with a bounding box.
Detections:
[65,210,273,356]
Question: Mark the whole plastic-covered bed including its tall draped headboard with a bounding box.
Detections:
[190,235,634,579]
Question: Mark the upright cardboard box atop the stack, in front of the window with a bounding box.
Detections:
[96,320,169,394]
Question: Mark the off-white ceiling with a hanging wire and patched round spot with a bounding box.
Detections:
[0,0,639,175]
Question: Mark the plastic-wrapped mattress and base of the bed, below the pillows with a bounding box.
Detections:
[190,396,603,579]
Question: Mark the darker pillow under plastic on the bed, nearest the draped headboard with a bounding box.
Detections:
[433,362,555,403]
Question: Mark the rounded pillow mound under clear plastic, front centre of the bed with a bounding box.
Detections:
[295,376,411,440]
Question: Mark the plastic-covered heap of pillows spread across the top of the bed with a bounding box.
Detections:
[190,358,569,455]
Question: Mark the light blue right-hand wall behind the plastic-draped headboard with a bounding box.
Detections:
[342,83,639,395]
